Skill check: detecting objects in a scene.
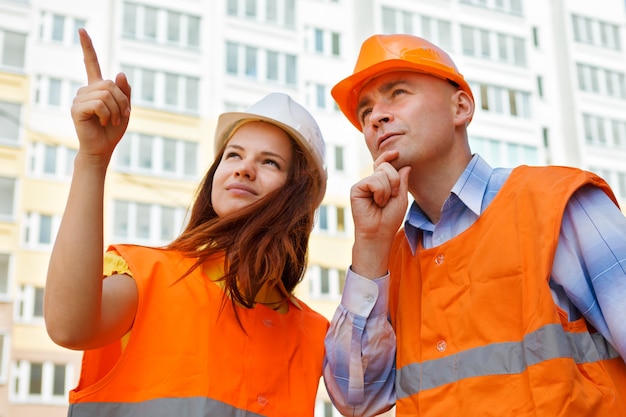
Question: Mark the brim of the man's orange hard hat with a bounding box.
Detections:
[331,59,474,131]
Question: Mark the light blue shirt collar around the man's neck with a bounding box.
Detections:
[404,154,493,250]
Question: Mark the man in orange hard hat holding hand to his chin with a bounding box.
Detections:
[324,35,626,417]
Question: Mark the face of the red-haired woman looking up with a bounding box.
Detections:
[211,122,294,217]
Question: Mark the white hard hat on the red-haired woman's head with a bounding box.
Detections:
[214,93,327,204]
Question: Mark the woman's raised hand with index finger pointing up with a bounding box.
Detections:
[72,29,130,163]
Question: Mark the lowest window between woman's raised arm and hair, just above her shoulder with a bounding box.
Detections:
[113,200,186,245]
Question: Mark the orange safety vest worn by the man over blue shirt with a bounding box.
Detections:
[390,167,626,417]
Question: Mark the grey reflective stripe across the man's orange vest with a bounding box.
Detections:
[396,324,619,398]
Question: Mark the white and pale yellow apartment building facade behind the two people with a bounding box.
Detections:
[0,0,626,417]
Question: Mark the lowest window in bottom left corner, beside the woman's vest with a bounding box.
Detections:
[9,360,74,404]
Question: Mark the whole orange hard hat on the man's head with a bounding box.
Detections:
[331,34,474,130]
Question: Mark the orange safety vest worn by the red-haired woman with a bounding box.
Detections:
[69,245,328,417]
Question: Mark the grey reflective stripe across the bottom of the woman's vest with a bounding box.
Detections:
[68,397,264,417]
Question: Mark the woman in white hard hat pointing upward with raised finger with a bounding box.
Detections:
[44,30,328,417]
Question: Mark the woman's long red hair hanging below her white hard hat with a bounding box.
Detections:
[167,133,322,308]
